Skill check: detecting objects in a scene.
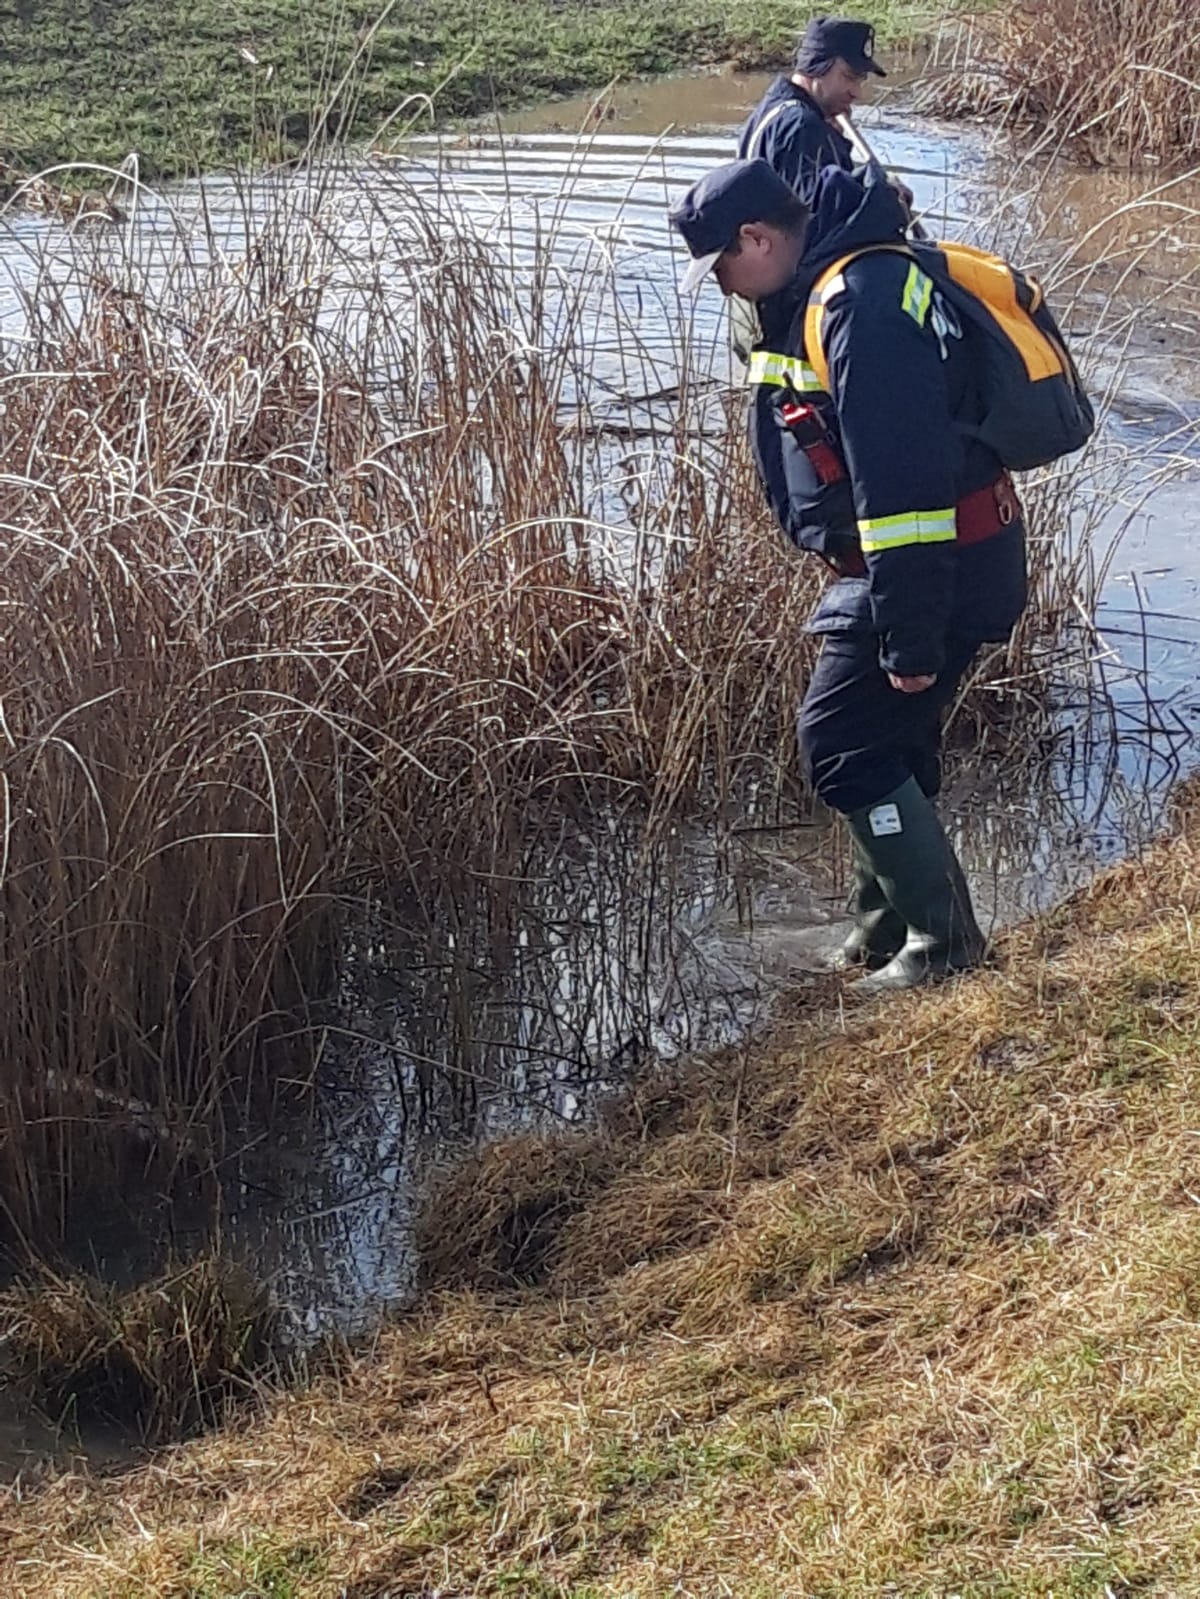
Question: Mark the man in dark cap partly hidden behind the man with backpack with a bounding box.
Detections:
[738,16,886,201]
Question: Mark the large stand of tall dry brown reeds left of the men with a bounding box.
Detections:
[0,127,1177,1239]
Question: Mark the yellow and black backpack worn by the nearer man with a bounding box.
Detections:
[805,243,1096,472]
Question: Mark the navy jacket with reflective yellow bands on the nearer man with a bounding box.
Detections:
[750,169,1026,676]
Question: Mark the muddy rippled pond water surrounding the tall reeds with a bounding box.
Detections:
[0,74,1200,1457]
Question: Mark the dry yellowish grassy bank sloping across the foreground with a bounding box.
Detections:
[0,803,1200,1599]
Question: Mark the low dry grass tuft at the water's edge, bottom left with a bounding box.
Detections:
[0,1255,278,1444]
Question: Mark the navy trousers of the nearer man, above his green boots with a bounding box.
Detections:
[798,630,979,815]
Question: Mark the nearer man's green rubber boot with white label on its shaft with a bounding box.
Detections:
[846,777,986,996]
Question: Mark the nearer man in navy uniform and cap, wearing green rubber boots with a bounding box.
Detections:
[670,160,1026,993]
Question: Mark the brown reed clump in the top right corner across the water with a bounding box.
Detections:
[920,0,1200,166]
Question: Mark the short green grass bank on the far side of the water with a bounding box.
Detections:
[0,0,947,176]
